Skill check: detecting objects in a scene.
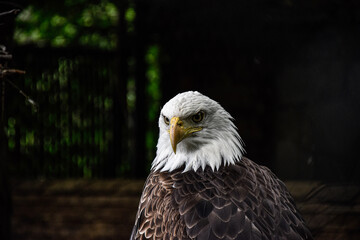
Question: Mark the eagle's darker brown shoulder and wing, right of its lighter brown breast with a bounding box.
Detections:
[173,158,312,240]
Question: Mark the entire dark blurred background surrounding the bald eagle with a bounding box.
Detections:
[0,0,360,239]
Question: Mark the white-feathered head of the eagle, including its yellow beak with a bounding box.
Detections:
[152,91,244,172]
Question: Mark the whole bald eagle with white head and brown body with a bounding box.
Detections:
[130,91,312,240]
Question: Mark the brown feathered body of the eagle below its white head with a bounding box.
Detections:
[131,158,312,240]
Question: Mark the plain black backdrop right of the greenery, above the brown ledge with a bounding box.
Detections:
[153,1,360,181]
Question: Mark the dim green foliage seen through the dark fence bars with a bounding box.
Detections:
[6,56,119,178]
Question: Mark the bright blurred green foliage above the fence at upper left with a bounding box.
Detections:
[14,0,119,50]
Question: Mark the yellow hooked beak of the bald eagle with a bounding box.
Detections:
[169,117,202,154]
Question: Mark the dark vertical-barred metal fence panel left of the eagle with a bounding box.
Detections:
[5,48,134,178]
